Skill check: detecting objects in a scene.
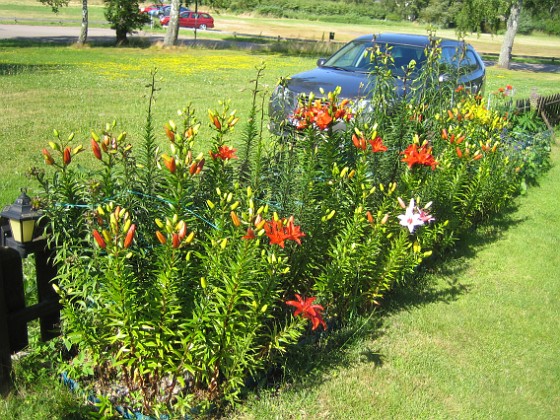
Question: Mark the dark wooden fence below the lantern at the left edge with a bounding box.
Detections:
[0,226,60,393]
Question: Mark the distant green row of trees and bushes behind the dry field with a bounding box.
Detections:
[228,0,560,35]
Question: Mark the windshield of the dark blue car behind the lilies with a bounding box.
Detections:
[323,41,426,75]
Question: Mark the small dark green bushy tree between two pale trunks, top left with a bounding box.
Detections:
[104,0,149,45]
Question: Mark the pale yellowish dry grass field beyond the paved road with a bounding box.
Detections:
[0,0,560,58]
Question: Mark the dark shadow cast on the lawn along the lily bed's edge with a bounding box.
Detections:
[248,205,527,404]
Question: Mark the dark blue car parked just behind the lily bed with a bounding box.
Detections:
[269,33,486,134]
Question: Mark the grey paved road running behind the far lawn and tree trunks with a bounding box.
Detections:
[0,24,560,73]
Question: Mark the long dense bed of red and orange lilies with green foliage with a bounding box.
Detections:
[28,41,547,415]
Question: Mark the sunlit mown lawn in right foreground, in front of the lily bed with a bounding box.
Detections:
[234,142,560,419]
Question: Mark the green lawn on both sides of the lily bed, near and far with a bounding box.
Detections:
[0,32,560,419]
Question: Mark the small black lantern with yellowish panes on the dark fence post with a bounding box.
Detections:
[0,188,41,243]
